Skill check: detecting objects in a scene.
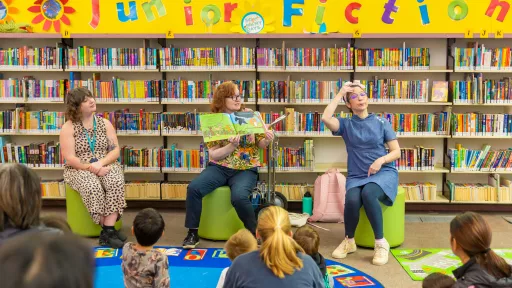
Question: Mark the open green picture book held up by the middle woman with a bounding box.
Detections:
[199,111,265,142]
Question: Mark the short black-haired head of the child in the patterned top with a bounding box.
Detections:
[132,208,165,247]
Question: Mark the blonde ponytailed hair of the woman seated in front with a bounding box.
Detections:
[257,206,304,278]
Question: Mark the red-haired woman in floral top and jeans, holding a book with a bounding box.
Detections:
[183,82,274,249]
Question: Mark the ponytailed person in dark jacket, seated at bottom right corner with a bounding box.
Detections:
[450,212,512,288]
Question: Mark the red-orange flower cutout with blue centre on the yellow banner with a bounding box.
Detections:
[27,0,75,33]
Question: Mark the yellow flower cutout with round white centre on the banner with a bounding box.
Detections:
[231,0,276,34]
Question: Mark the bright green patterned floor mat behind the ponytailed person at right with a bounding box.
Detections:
[391,249,512,281]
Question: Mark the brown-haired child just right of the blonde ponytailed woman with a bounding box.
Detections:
[293,225,334,288]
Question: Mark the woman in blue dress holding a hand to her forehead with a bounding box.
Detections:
[322,82,400,265]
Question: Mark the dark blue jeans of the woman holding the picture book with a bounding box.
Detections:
[185,164,258,234]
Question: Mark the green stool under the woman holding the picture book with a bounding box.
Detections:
[198,186,244,240]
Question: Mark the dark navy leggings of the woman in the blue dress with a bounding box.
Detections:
[344,182,388,239]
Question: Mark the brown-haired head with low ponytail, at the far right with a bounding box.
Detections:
[450,212,512,278]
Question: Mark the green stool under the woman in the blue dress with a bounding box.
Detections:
[355,188,405,248]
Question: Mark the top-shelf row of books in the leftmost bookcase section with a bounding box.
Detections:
[0,46,65,71]
